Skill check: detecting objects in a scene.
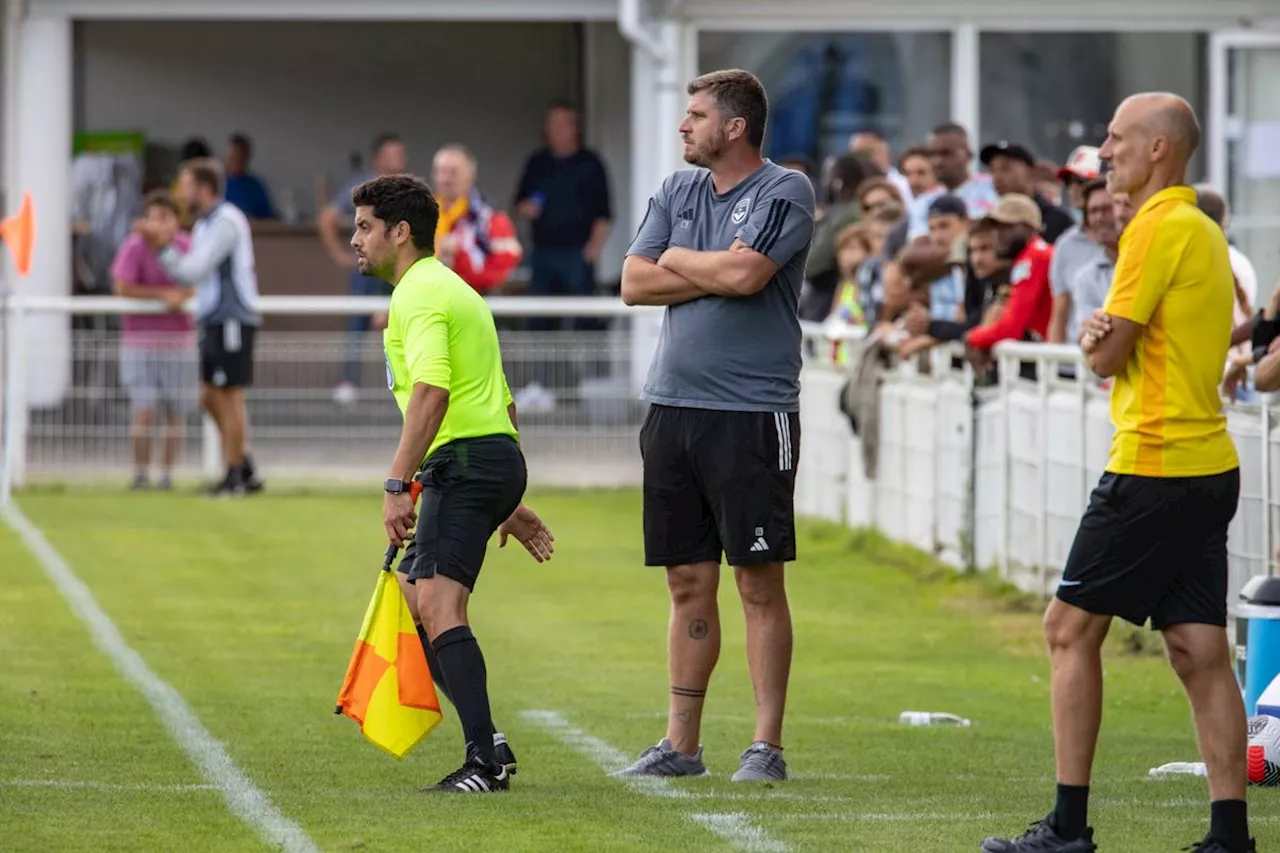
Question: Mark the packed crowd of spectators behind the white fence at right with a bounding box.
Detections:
[791,123,1264,409]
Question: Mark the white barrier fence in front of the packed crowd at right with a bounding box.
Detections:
[796,327,1280,606]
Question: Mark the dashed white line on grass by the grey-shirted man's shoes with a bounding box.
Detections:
[520,711,791,853]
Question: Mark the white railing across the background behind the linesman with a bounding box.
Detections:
[0,296,658,500]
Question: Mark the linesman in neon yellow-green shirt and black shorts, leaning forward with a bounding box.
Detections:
[351,174,552,793]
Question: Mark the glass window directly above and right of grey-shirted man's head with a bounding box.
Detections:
[698,31,951,163]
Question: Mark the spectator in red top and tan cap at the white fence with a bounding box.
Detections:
[965,195,1053,350]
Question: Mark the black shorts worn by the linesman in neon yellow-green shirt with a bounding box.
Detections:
[398,435,527,590]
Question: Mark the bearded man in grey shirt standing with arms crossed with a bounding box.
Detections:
[620,70,814,781]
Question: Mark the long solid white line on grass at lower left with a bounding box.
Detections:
[0,503,319,853]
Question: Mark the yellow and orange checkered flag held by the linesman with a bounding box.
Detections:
[334,563,442,758]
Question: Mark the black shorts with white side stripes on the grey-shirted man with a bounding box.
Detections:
[640,406,800,566]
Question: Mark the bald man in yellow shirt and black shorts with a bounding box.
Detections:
[982,93,1254,853]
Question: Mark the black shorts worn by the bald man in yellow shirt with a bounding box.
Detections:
[1057,469,1240,630]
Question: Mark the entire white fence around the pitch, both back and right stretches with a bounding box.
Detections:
[0,297,1280,601]
